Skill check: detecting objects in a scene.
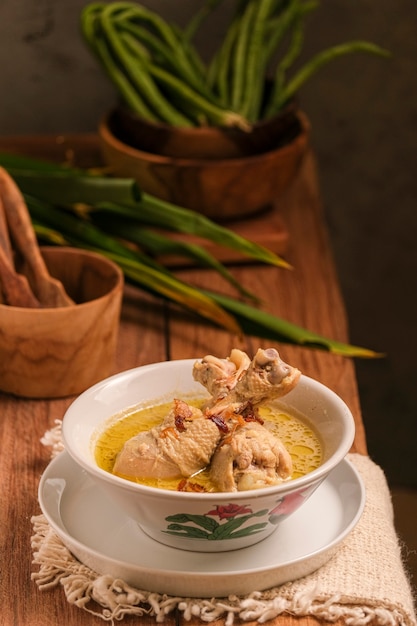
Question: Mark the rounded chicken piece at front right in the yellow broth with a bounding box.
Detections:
[210,422,292,491]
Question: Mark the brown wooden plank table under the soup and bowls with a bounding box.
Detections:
[0,136,366,626]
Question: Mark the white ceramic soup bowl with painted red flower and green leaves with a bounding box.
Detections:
[62,359,355,552]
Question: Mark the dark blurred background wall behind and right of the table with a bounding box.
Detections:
[0,0,417,487]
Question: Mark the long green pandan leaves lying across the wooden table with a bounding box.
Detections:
[0,153,380,358]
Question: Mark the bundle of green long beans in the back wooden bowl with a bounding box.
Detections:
[81,0,388,130]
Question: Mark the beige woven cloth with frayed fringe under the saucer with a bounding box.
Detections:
[32,423,417,626]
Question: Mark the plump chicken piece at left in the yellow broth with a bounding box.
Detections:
[113,400,220,479]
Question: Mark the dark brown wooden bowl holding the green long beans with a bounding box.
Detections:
[99,111,309,221]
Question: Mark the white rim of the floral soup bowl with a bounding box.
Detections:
[62,358,356,502]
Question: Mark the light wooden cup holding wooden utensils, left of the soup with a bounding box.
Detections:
[0,247,123,398]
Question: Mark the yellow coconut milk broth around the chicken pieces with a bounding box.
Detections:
[95,399,322,491]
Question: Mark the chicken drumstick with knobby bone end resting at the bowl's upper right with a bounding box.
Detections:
[201,348,301,415]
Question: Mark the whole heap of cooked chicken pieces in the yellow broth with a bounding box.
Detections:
[113,348,300,491]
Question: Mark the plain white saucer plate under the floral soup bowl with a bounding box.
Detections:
[39,452,365,598]
